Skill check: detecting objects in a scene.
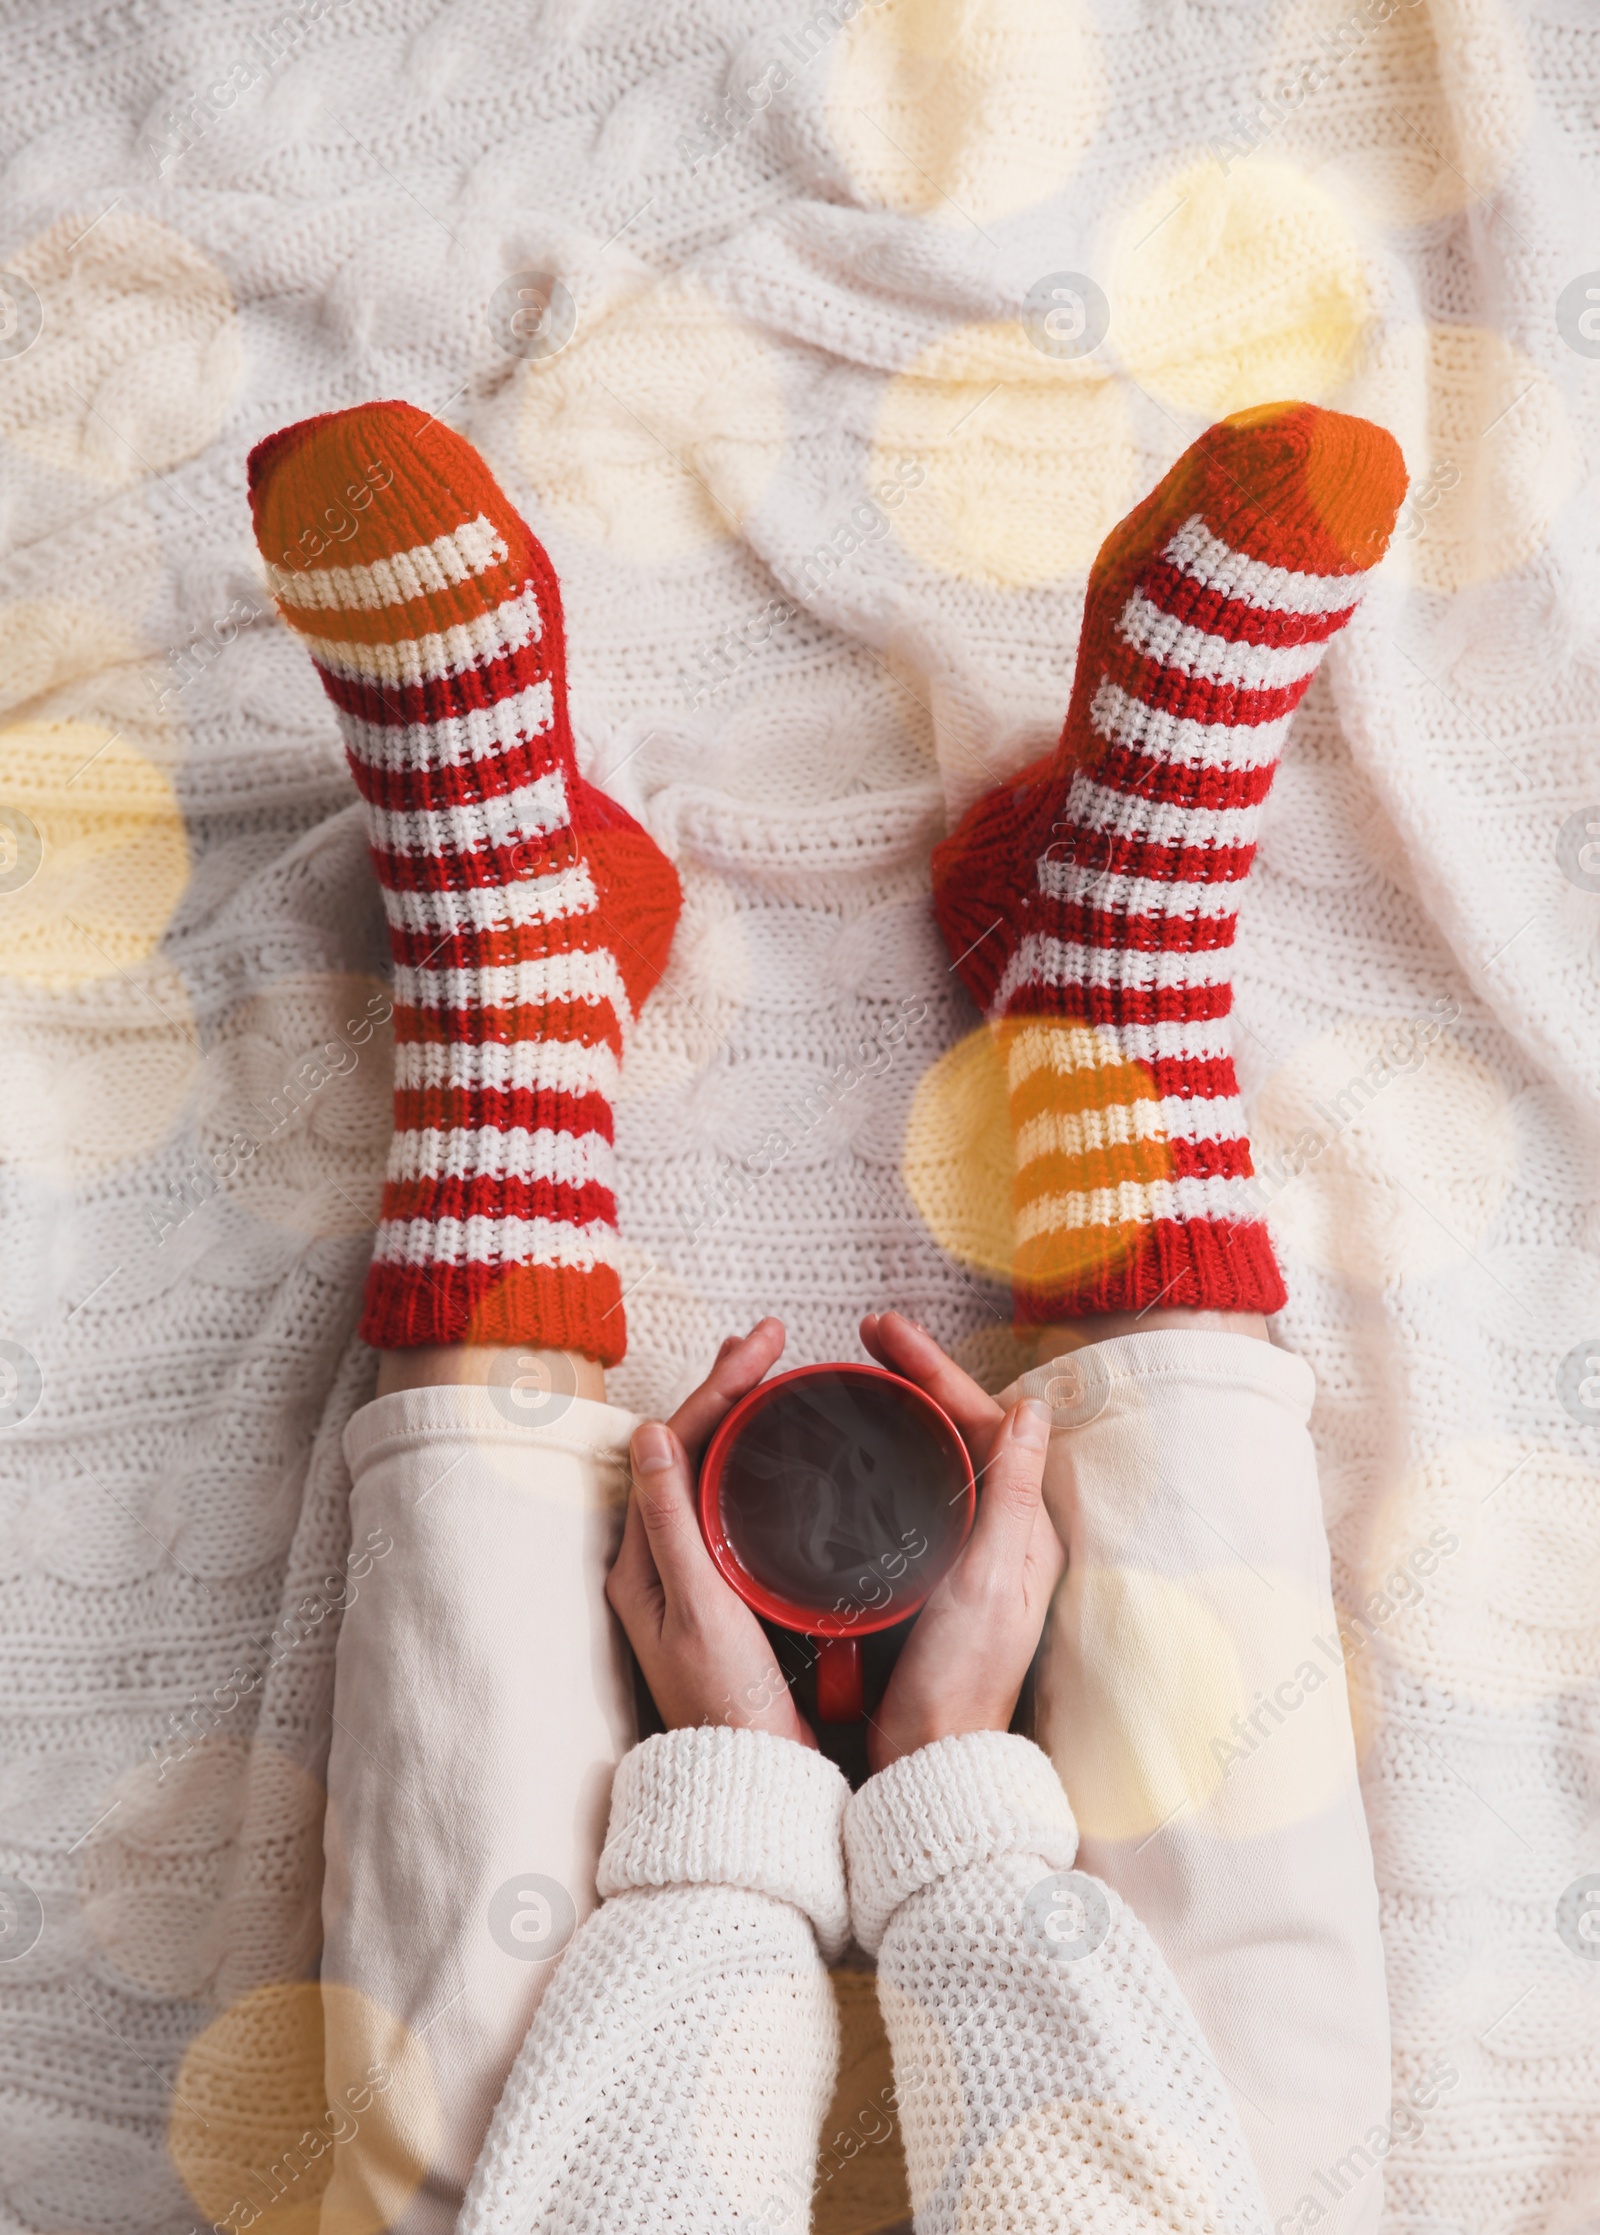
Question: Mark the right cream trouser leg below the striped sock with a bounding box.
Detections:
[1018,1314,1390,2235]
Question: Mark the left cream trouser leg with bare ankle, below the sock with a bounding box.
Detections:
[322,1352,637,2235]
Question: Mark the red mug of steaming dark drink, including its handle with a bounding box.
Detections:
[699,1366,977,1723]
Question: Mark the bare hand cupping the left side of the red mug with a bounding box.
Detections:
[606,1319,816,1746]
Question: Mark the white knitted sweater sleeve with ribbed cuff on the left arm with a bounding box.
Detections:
[458,1730,849,2235]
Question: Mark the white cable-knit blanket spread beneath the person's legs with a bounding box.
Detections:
[0,0,1600,2235]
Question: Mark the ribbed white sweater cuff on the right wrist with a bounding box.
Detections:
[845,1730,1077,1956]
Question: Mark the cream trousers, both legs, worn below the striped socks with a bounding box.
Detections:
[322,1330,1390,2235]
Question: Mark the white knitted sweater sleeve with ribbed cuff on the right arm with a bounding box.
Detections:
[845,1732,1267,2235]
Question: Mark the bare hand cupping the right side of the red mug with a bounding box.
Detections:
[863,1385,1066,1770]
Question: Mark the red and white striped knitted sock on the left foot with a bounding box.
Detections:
[250,402,679,1366]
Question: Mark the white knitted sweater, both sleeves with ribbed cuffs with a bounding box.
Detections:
[458,1730,1265,2235]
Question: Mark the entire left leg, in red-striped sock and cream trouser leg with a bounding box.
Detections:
[250,402,679,2231]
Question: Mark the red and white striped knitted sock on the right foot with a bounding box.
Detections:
[934,405,1406,1325]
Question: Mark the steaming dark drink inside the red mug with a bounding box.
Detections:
[717,1372,970,1629]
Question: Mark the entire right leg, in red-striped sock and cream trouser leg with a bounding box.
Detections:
[934,405,1406,2235]
